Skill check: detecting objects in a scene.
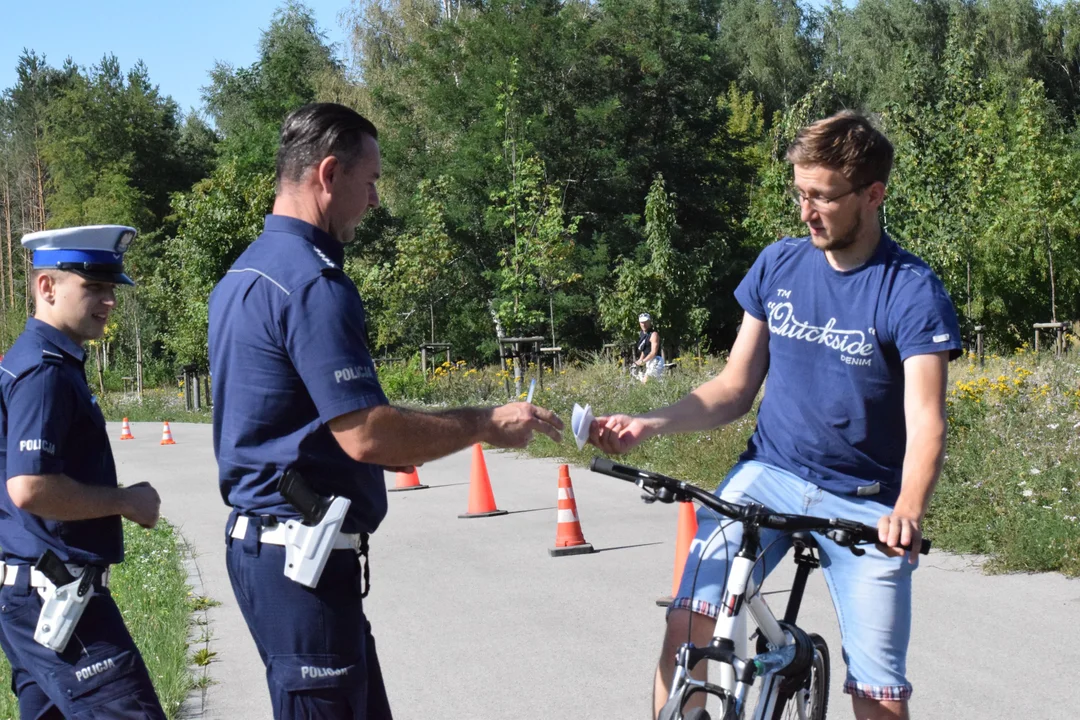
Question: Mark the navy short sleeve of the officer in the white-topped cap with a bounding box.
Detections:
[4,365,75,480]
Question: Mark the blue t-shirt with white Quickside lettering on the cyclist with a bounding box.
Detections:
[735,234,960,505]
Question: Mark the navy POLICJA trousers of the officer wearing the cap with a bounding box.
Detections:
[0,567,165,720]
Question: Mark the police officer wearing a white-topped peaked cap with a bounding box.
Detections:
[0,226,165,720]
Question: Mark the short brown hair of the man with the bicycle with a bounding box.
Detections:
[787,110,893,187]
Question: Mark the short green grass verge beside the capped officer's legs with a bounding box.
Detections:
[0,520,194,720]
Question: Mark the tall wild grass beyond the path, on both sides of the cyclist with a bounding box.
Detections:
[408,350,1080,576]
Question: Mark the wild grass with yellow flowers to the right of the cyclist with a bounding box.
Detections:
[928,353,1080,576]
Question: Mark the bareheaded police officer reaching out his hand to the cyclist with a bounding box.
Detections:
[210,104,563,720]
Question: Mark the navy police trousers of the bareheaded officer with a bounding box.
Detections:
[226,513,392,720]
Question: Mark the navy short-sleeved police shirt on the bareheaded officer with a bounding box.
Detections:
[210,215,387,532]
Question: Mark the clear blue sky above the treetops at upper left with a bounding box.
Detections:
[0,0,351,111]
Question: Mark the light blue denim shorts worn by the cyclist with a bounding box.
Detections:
[669,461,917,699]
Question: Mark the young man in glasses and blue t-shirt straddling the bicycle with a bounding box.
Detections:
[590,112,960,720]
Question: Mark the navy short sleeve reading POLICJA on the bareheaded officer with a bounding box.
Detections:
[283,276,387,422]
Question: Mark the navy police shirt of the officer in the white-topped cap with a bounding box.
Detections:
[0,317,124,565]
